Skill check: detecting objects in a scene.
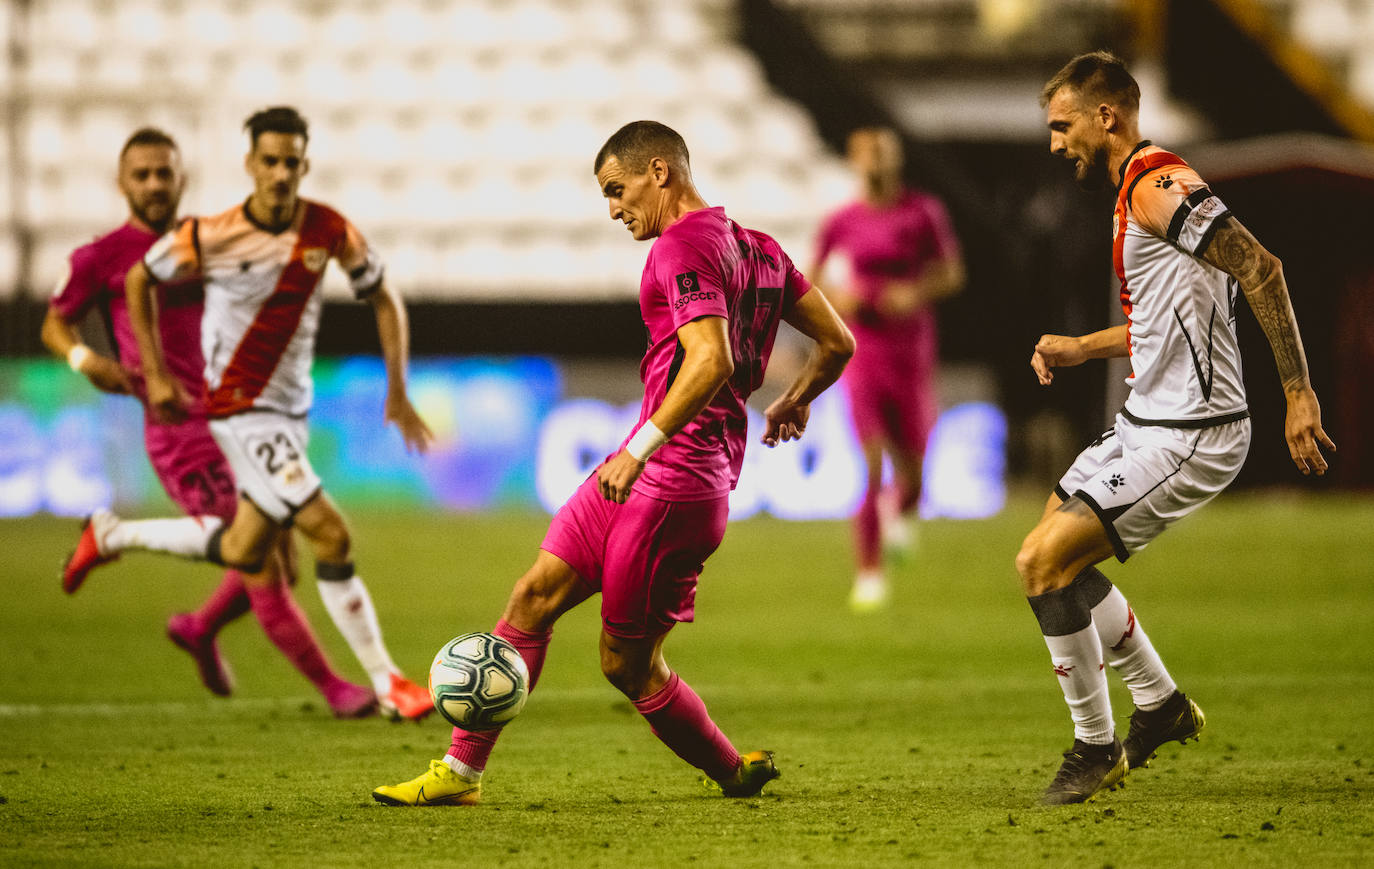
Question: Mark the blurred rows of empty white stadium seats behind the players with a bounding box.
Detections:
[0,0,851,298]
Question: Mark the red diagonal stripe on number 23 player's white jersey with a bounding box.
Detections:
[207,201,345,418]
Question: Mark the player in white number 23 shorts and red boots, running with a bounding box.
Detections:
[65,106,433,718]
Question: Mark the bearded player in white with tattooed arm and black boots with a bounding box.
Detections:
[1033,52,1336,804]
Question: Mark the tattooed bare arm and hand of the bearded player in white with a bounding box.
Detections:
[1198,215,1336,474]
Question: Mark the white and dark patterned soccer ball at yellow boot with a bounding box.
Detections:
[430,634,529,730]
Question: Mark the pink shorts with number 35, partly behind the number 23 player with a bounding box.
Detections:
[143,419,239,521]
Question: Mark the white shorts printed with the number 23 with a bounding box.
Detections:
[210,411,320,523]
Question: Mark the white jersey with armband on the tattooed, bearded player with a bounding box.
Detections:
[1112,142,1246,428]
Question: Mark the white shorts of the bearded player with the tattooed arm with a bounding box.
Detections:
[1054,414,1250,561]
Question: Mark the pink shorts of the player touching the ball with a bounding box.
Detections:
[540,473,730,639]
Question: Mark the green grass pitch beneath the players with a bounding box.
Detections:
[0,494,1374,868]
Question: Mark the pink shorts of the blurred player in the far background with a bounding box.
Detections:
[842,364,937,455]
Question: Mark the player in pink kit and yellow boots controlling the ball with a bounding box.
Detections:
[372,121,853,806]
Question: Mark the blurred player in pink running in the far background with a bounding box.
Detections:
[811,128,965,612]
